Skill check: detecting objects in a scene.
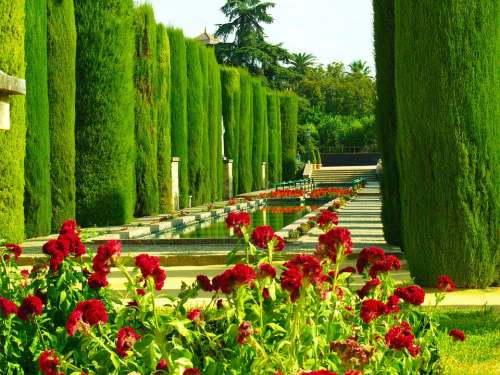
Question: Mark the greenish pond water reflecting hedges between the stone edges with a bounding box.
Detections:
[149,203,319,239]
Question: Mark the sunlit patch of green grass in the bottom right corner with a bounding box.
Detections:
[438,306,500,375]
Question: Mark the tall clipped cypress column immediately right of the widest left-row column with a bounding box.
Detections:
[134,4,159,217]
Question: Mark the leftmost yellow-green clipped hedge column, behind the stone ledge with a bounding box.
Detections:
[0,0,26,242]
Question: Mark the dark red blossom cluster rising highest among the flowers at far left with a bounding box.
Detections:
[42,220,86,272]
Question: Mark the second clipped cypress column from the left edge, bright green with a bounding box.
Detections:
[24,0,52,237]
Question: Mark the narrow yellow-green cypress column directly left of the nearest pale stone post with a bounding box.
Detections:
[156,24,172,213]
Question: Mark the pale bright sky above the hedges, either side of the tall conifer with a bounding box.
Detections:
[143,0,375,71]
